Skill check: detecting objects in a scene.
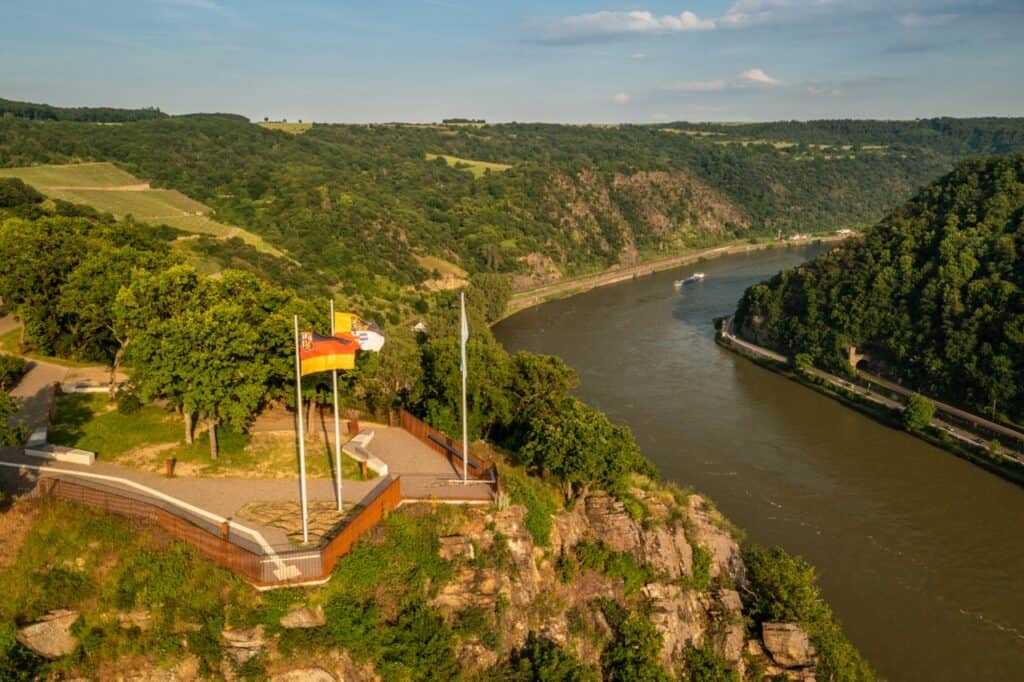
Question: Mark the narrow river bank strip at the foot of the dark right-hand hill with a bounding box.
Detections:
[715,316,1024,485]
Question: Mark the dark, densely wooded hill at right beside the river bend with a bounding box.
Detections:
[736,153,1024,421]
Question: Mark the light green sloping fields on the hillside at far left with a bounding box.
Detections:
[0,163,283,256]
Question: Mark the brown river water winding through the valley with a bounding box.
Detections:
[494,246,1024,680]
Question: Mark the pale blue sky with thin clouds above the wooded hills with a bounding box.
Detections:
[0,0,1024,123]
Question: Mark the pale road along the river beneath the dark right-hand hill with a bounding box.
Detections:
[722,316,1024,462]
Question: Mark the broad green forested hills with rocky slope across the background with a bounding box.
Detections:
[0,108,1024,299]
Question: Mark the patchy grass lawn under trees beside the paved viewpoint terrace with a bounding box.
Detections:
[50,394,375,479]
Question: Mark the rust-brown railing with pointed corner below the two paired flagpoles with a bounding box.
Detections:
[39,476,401,587]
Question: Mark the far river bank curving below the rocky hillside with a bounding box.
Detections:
[499,233,853,322]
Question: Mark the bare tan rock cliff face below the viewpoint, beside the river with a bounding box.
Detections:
[431,489,815,679]
